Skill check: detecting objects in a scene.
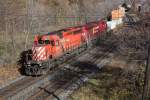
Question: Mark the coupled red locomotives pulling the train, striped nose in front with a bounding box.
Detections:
[25,20,107,75]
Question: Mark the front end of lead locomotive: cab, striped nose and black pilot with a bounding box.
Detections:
[25,36,55,75]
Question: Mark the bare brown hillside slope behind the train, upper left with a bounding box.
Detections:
[0,0,123,65]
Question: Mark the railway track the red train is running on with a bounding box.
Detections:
[0,44,98,100]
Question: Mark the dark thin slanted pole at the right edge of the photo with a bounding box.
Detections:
[142,42,150,100]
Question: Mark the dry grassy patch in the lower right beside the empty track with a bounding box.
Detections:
[68,57,143,100]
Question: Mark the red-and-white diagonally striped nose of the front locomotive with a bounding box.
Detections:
[32,46,47,61]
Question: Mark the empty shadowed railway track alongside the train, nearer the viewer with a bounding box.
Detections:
[28,45,113,100]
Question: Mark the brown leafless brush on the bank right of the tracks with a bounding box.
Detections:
[106,19,150,60]
